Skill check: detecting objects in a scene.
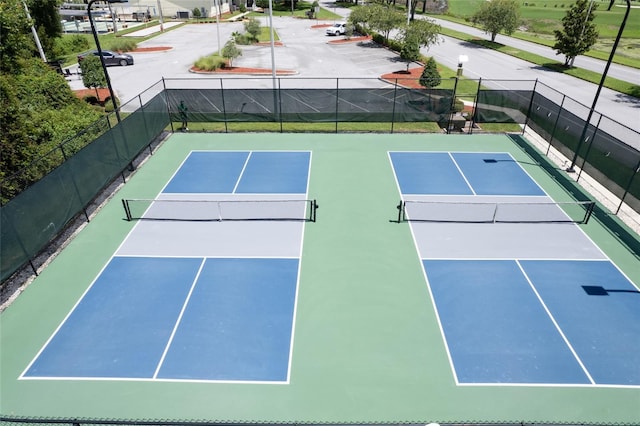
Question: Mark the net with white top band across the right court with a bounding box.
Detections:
[397,200,595,223]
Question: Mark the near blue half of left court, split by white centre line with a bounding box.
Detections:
[25,257,298,381]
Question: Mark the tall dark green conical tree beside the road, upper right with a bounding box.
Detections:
[553,0,598,67]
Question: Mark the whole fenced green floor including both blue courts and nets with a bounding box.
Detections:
[1,134,640,424]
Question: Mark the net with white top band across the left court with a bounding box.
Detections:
[122,198,318,222]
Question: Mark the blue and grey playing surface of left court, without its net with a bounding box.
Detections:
[23,151,311,383]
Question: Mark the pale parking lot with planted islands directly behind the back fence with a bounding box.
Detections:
[70,16,406,104]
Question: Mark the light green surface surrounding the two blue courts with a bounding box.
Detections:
[0,133,640,424]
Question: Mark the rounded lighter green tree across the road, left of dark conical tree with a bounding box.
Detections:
[471,0,520,41]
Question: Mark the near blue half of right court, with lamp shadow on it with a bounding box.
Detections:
[423,259,640,385]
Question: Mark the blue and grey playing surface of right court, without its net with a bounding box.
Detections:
[389,152,640,386]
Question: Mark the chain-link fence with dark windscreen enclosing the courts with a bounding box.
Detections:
[0,78,640,281]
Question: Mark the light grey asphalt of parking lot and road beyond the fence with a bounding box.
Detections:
[70,2,640,138]
